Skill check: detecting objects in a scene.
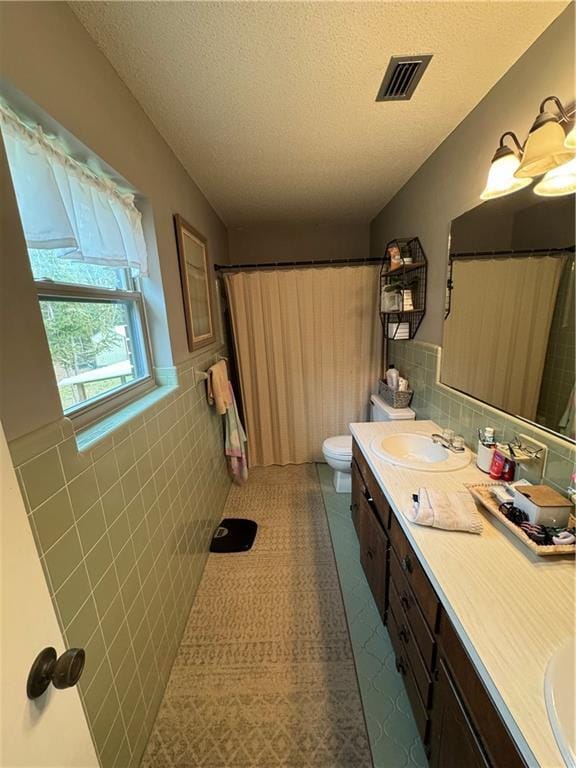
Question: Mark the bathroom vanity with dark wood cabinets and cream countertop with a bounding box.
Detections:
[351,421,574,768]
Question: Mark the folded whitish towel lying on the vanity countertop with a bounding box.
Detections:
[408,488,482,533]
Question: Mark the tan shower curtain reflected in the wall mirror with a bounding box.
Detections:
[441,255,563,421]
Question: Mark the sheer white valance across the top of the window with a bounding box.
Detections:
[0,102,148,275]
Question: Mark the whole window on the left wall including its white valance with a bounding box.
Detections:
[0,104,153,424]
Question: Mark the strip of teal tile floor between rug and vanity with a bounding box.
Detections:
[317,464,428,768]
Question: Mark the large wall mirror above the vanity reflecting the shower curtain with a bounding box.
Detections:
[440,188,575,440]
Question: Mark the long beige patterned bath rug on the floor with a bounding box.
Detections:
[142,465,372,768]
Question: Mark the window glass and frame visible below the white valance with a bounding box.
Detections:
[29,254,150,414]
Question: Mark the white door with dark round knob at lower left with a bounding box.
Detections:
[0,425,98,768]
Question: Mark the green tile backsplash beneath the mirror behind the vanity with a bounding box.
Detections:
[388,341,576,491]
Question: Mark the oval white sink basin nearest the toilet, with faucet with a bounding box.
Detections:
[370,432,471,472]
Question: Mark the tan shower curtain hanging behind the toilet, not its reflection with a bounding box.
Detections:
[225,266,382,466]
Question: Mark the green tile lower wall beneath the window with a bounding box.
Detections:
[10,352,230,768]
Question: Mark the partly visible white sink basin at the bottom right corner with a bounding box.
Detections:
[544,638,576,768]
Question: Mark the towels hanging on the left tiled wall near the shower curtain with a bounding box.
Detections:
[207,360,248,485]
